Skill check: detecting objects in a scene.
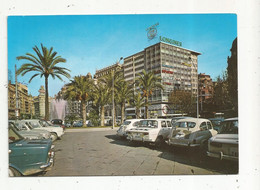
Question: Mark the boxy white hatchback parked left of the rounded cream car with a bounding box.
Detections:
[127,119,172,146]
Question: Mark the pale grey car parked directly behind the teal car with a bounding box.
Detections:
[9,120,51,139]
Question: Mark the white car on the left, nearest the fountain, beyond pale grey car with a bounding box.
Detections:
[24,119,64,141]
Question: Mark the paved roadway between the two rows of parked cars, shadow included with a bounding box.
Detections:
[42,129,238,176]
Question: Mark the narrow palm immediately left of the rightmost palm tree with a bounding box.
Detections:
[115,80,133,123]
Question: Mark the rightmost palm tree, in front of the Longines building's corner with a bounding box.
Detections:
[136,70,163,118]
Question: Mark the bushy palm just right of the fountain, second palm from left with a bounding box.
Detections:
[64,75,93,126]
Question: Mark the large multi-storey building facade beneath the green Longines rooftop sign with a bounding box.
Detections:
[123,42,200,117]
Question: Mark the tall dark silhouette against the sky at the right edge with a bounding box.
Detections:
[227,38,238,115]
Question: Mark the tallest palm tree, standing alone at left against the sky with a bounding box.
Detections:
[16,44,70,120]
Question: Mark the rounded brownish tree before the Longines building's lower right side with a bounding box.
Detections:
[169,89,195,113]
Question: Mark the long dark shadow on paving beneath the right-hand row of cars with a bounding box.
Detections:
[105,135,238,174]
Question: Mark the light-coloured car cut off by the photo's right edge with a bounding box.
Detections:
[207,117,238,161]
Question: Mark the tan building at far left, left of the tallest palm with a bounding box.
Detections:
[8,81,35,119]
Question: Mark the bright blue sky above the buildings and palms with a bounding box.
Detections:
[8,14,237,96]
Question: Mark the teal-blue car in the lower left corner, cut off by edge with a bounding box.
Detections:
[8,125,54,176]
